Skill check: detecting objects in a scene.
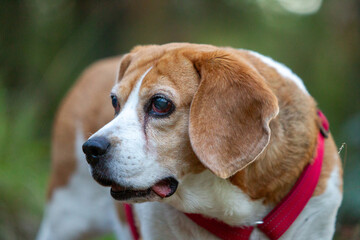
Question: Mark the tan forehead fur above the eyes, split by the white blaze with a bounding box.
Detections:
[113,50,198,103]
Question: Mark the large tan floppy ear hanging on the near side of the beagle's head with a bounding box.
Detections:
[184,50,279,179]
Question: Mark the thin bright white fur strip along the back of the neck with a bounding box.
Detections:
[247,50,309,95]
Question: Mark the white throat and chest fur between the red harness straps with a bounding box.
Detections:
[134,170,270,240]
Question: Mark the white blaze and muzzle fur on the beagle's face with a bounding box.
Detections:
[91,68,170,189]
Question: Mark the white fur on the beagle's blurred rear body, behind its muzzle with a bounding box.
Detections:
[36,128,130,240]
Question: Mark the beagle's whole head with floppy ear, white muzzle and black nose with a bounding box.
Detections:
[83,44,278,202]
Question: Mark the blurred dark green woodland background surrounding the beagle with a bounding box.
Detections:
[0,0,360,239]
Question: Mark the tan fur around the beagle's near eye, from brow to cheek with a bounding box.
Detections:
[139,51,205,177]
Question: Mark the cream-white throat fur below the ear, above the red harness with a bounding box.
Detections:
[166,170,272,225]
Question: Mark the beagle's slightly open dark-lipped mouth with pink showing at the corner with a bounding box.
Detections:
[110,177,178,201]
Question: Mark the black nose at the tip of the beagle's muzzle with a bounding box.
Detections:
[83,137,110,164]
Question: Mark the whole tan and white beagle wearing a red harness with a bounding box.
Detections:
[38,43,342,240]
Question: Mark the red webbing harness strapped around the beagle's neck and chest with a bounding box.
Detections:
[125,111,329,240]
